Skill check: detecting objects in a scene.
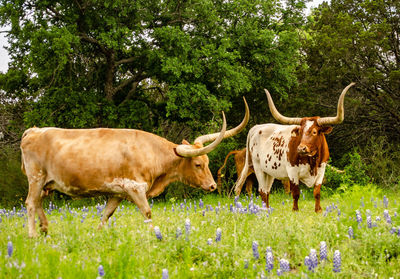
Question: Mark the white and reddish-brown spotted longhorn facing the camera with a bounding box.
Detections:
[235,83,354,212]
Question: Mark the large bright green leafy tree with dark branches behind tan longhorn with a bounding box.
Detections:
[0,0,305,139]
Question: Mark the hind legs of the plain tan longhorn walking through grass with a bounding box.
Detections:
[25,170,47,237]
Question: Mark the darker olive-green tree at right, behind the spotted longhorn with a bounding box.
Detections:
[304,0,400,158]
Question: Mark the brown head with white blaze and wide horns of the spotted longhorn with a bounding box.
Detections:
[265,83,355,159]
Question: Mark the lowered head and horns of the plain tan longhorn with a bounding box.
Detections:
[175,98,250,191]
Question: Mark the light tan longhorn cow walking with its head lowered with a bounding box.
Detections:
[21,98,249,237]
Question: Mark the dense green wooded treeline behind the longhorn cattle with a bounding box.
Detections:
[0,0,400,206]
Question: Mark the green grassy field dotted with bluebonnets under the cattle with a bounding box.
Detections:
[0,186,400,279]
